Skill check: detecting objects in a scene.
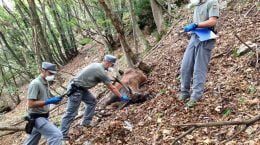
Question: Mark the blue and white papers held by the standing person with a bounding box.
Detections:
[191,28,218,41]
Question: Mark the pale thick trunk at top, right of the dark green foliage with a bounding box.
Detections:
[150,0,164,34]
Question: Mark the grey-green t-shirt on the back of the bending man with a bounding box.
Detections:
[71,63,111,89]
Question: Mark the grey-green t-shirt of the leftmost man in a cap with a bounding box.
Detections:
[27,76,50,114]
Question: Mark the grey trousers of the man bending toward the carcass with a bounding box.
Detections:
[61,91,97,137]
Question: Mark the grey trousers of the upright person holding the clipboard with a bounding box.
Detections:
[181,34,215,101]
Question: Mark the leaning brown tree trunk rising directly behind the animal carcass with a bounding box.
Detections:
[98,0,137,67]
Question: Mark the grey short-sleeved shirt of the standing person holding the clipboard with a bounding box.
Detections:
[193,0,219,24]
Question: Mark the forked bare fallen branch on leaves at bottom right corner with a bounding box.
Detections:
[172,114,260,145]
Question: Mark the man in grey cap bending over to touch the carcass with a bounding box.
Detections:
[61,55,129,140]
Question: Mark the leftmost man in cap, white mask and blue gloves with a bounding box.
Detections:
[24,62,62,145]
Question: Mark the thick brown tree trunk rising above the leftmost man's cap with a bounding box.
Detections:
[27,0,53,62]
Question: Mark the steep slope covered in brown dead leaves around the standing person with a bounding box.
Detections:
[72,0,260,145]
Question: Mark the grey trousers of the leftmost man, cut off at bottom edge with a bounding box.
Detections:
[24,117,62,145]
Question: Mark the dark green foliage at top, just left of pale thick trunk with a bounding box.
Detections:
[135,0,155,29]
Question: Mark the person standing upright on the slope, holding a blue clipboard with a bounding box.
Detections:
[178,0,219,107]
